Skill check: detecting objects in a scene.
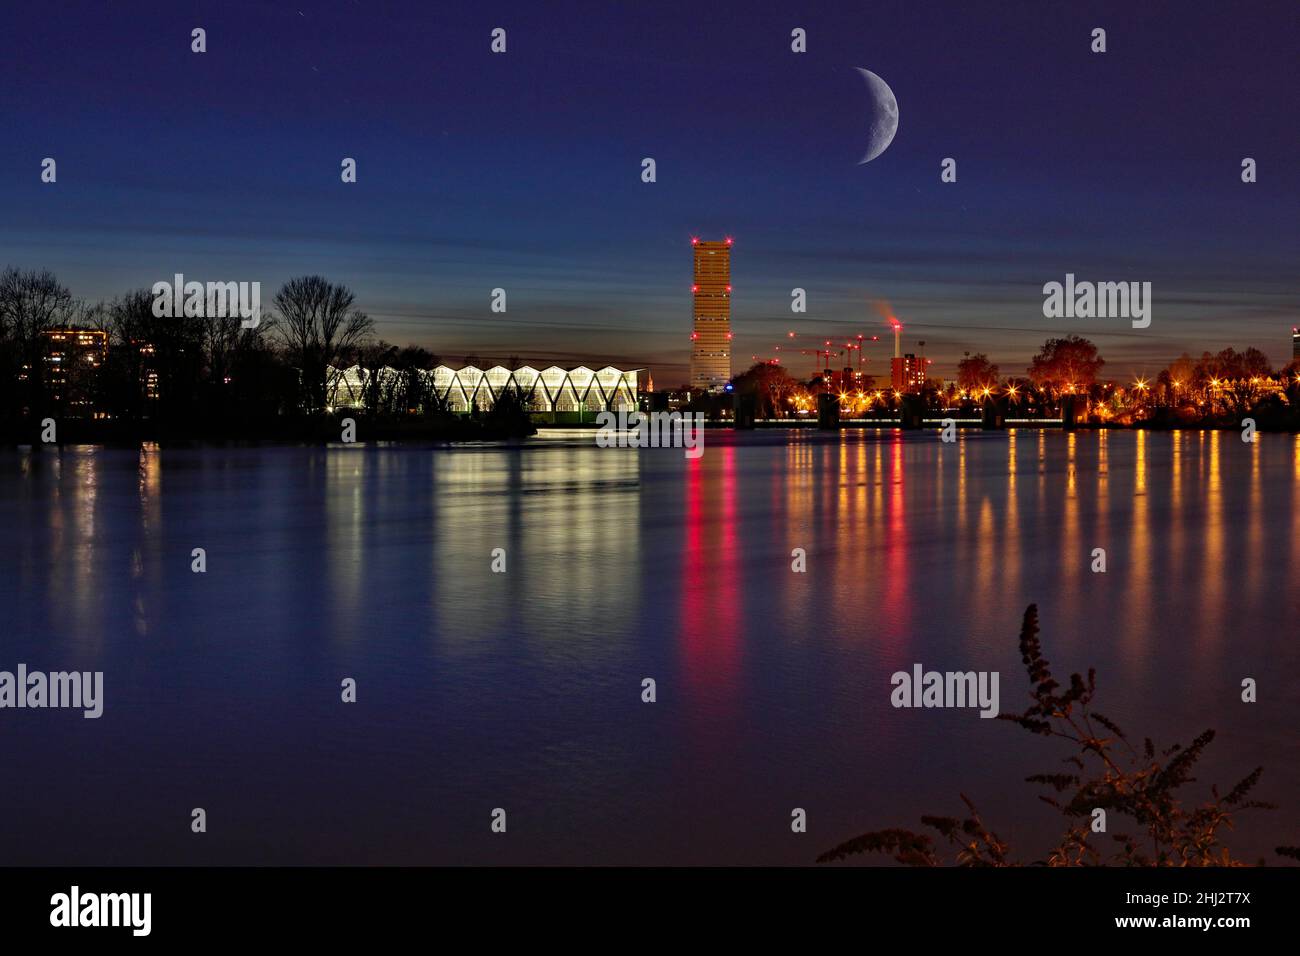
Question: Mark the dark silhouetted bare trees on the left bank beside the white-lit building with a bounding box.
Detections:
[0,267,496,436]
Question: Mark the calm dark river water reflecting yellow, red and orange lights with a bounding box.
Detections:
[0,431,1300,864]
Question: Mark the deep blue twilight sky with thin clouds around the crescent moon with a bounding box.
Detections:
[0,0,1300,385]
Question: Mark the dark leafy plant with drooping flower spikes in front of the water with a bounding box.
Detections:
[818,605,1300,866]
